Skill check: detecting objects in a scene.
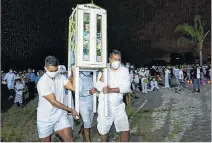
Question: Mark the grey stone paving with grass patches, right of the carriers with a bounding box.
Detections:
[129,85,211,142]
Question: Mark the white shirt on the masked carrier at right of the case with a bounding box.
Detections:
[107,67,130,105]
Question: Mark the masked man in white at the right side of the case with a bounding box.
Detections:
[97,50,130,142]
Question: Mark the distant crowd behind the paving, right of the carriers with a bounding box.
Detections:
[126,64,211,93]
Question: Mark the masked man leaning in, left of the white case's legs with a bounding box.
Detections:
[37,56,79,142]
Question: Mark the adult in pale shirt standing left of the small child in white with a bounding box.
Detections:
[4,69,16,99]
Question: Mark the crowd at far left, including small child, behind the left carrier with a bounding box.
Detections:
[1,68,43,108]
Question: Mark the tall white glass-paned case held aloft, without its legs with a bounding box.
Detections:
[68,4,107,69]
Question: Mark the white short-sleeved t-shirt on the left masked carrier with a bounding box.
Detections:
[37,74,68,122]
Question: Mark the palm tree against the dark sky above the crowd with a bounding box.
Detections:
[175,15,210,66]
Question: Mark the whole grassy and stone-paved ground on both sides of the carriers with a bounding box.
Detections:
[1,85,211,142]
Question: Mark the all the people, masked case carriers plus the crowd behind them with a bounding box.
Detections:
[1,50,211,142]
